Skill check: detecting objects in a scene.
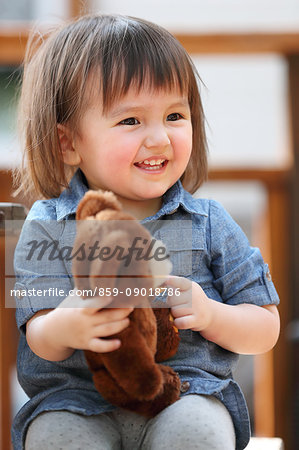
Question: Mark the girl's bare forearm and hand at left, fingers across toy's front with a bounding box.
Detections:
[26,296,133,361]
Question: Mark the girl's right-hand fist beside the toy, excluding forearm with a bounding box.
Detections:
[165,277,212,331]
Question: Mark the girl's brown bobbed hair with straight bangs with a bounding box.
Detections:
[15,15,207,198]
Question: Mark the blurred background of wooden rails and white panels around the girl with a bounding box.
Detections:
[0,0,299,450]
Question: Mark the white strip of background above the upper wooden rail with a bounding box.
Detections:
[90,0,299,31]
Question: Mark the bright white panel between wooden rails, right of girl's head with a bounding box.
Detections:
[194,55,290,167]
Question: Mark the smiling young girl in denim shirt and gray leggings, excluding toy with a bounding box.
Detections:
[12,15,279,450]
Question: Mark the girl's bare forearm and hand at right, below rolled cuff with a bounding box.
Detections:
[167,277,280,354]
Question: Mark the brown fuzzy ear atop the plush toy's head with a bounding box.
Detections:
[76,190,121,220]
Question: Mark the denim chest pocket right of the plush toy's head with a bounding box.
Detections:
[157,228,206,277]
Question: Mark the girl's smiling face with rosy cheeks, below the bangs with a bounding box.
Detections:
[66,88,192,214]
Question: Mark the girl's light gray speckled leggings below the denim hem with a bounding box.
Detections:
[25,395,235,450]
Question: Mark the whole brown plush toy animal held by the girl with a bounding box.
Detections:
[72,191,180,417]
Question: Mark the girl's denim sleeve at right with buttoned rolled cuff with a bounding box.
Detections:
[210,201,279,306]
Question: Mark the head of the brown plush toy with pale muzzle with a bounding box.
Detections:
[73,190,172,306]
